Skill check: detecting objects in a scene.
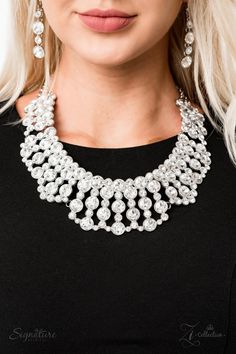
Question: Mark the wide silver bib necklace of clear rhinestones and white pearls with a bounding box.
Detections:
[20,85,211,235]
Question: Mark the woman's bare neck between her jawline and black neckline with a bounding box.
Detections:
[49,34,181,147]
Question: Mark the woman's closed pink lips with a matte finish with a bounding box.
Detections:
[79,9,136,32]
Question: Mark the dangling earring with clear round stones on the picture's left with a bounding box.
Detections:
[33,0,45,59]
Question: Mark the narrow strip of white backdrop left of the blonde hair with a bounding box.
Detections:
[0,0,10,68]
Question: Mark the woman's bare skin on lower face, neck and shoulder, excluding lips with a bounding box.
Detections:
[16,0,188,148]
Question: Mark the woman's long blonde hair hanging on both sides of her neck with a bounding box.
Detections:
[0,0,236,166]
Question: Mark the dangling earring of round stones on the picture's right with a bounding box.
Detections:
[181,6,195,69]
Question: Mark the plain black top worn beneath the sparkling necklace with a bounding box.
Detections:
[0,100,236,354]
